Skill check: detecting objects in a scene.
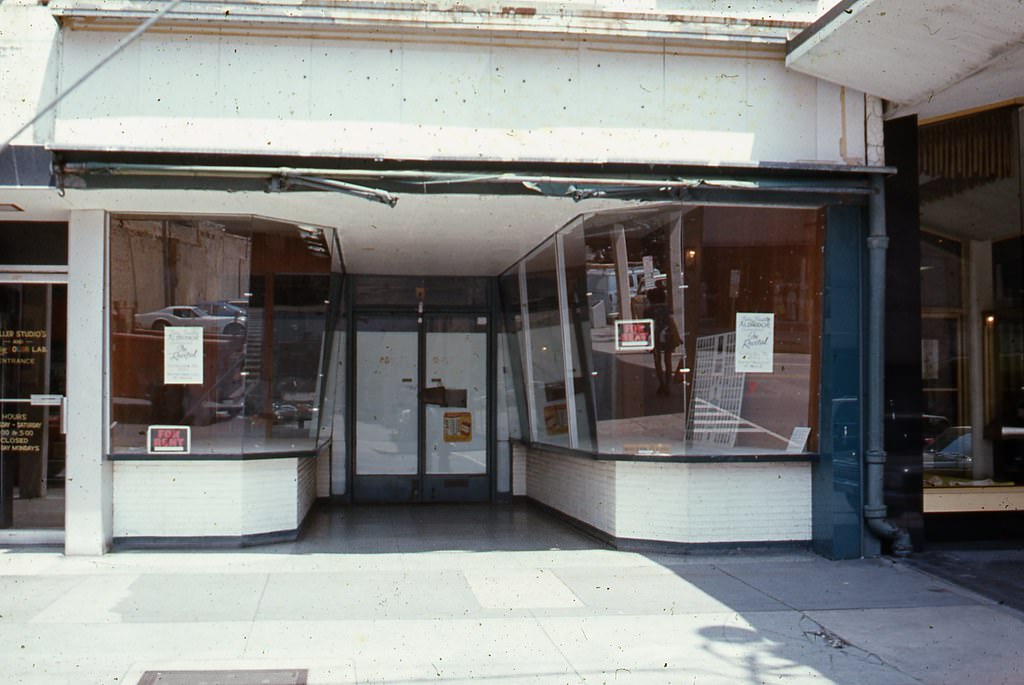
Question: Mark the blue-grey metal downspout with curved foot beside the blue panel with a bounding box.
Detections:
[864,174,913,557]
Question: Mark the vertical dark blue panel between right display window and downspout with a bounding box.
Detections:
[812,201,866,559]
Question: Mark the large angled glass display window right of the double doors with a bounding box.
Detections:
[502,203,824,457]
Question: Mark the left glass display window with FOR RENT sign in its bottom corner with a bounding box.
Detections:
[110,216,339,456]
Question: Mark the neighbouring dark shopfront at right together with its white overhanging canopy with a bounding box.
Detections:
[788,0,1024,546]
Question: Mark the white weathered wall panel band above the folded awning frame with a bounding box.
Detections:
[46,24,864,163]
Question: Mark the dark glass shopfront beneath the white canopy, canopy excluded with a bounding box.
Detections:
[891,105,1024,540]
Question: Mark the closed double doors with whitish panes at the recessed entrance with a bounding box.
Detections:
[352,313,490,503]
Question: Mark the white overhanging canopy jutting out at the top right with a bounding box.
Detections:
[786,0,1024,119]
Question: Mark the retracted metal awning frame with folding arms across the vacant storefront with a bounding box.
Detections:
[54,153,895,207]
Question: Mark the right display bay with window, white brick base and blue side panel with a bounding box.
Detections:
[501,196,864,555]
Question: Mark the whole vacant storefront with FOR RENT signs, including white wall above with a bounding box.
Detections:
[3,0,892,557]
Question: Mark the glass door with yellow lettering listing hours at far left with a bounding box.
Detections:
[0,282,66,529]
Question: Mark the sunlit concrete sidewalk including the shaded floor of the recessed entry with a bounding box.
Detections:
[0,506,1024,685]
